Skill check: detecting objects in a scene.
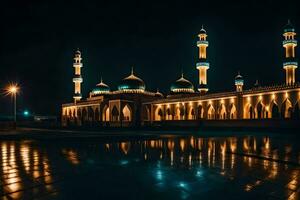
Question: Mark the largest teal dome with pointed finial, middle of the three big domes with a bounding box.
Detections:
[118,70,146,93]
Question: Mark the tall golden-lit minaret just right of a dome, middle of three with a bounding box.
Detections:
[196,26,209,94]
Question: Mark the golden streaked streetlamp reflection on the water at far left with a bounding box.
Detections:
[0,141,53,199]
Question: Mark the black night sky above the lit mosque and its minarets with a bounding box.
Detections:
[0,0,300,114]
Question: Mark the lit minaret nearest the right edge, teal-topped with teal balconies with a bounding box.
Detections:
[282,20,298,85]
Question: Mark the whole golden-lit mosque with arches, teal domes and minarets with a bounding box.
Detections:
[61,22,300,127]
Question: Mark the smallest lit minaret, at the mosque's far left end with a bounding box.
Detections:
[73,49,82,103]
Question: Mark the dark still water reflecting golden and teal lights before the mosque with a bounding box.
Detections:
[0,135,300,199]
